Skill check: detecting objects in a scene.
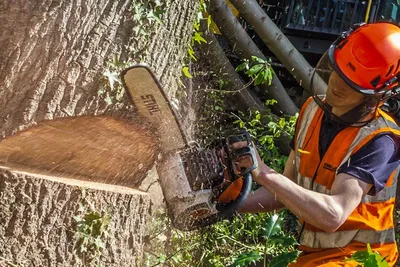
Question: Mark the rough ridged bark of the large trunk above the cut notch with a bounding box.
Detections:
[0,0,197,137]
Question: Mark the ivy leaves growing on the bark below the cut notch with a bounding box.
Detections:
[73,193,111,266]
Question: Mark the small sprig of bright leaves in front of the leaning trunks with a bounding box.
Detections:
[236,56,274,85]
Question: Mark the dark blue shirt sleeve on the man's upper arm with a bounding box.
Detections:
[337,134,400,195]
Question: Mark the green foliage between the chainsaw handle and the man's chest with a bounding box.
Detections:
[234,100,297,172]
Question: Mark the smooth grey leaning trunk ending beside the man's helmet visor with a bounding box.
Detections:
[231,0,326,95]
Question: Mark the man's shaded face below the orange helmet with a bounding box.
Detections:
[326,71,364,116]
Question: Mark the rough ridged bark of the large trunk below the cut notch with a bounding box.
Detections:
[0,170,150,266]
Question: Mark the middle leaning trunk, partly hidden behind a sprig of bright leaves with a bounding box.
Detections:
[210,0,298,115]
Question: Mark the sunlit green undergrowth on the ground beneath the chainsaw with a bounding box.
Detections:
[146,213,297,267]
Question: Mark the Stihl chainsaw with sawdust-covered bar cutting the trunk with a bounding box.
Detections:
[121,65,257,231]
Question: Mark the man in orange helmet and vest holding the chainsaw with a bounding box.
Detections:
[234,23,400,267]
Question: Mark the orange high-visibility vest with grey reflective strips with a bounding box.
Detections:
[291,98,400,267]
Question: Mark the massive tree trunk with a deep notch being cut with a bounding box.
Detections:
[0,0,198,266]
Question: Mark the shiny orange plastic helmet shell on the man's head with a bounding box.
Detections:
[329,22,400,94]
